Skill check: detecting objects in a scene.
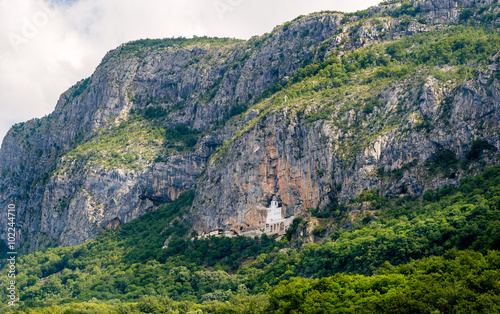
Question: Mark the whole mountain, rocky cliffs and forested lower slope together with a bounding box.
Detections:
[0,0,500,314]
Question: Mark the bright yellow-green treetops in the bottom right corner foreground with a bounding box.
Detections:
[266,250,500,314]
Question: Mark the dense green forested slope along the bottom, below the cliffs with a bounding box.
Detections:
[1,167,500,313]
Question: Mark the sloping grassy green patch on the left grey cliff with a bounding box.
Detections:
[54,112,207,175]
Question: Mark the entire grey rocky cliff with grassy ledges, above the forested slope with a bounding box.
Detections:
[0,1,500,250]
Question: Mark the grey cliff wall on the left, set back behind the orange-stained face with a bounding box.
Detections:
[0,14,342,250]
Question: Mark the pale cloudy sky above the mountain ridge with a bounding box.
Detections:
[0,0,380,145]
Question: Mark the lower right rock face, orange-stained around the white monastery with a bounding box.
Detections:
[193,63,500,233]
